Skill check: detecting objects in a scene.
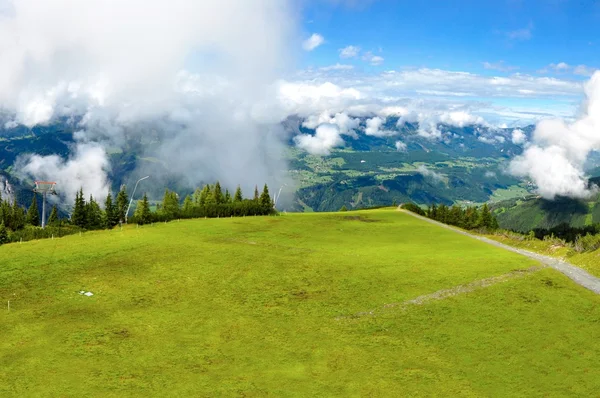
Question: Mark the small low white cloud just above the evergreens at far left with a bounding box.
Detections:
[17,143,110,202]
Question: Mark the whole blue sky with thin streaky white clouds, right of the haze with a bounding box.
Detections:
[286,0,600,124]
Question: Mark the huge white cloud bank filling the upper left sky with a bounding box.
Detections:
[0,0,297,200]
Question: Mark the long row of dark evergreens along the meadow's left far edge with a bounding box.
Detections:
[0,181,276,245]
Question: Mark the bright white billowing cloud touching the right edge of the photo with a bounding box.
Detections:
[509,72,600,199]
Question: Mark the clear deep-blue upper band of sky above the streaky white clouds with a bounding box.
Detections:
[303,0,600,74]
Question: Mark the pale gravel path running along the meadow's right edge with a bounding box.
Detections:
[399,209,600,294]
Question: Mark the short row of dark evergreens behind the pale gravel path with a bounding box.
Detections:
[402,203,498,230]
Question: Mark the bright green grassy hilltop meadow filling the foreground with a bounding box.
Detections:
[0,210,600,397]
